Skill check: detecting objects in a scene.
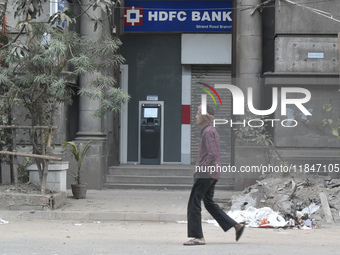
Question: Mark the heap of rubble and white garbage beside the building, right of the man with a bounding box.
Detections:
[228,173,340,229]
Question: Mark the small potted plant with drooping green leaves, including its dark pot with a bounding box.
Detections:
[63,140,93,199]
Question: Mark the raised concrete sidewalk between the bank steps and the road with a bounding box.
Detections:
[0,189,234,222]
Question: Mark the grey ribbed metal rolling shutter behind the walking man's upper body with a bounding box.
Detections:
[191,65,232,165]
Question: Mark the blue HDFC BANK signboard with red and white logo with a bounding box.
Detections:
[124,0,232,33]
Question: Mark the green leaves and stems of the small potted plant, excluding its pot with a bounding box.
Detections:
[63,140,94,184]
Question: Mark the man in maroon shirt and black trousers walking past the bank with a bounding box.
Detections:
[183,105,245,245]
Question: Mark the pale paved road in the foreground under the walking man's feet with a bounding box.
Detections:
[0,219,340,255]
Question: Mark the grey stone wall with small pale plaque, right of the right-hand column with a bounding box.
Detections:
[264,0,340,171]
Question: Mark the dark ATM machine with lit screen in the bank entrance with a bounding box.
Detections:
[138,101,164,165]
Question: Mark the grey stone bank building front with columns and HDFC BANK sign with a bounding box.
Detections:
[1,0,340,190]
